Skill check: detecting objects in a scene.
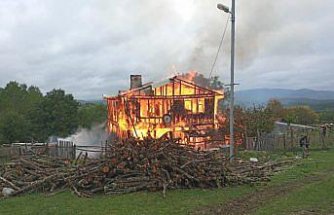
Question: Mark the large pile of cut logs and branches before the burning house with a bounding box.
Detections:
[0,140,292,197]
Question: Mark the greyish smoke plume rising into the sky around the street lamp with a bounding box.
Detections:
[188,0,284,74]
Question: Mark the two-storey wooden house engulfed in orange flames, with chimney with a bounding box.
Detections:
[105,75,223,148]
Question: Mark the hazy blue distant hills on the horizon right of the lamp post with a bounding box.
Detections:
[235,89,334,111]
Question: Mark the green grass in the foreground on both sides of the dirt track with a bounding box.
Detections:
[0,150,334,215]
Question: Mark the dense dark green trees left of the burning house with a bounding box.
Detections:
[0,82,106,144]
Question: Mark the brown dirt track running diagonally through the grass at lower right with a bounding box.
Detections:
[193,169,334,215]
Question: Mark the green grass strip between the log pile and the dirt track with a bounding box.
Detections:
[0,186,252,215]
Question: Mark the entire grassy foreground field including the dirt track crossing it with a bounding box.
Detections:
[0,150,334,215]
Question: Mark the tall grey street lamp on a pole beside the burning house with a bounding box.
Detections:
[217,0,235,161]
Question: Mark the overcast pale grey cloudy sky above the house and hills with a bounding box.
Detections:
[0,0,334,100]
